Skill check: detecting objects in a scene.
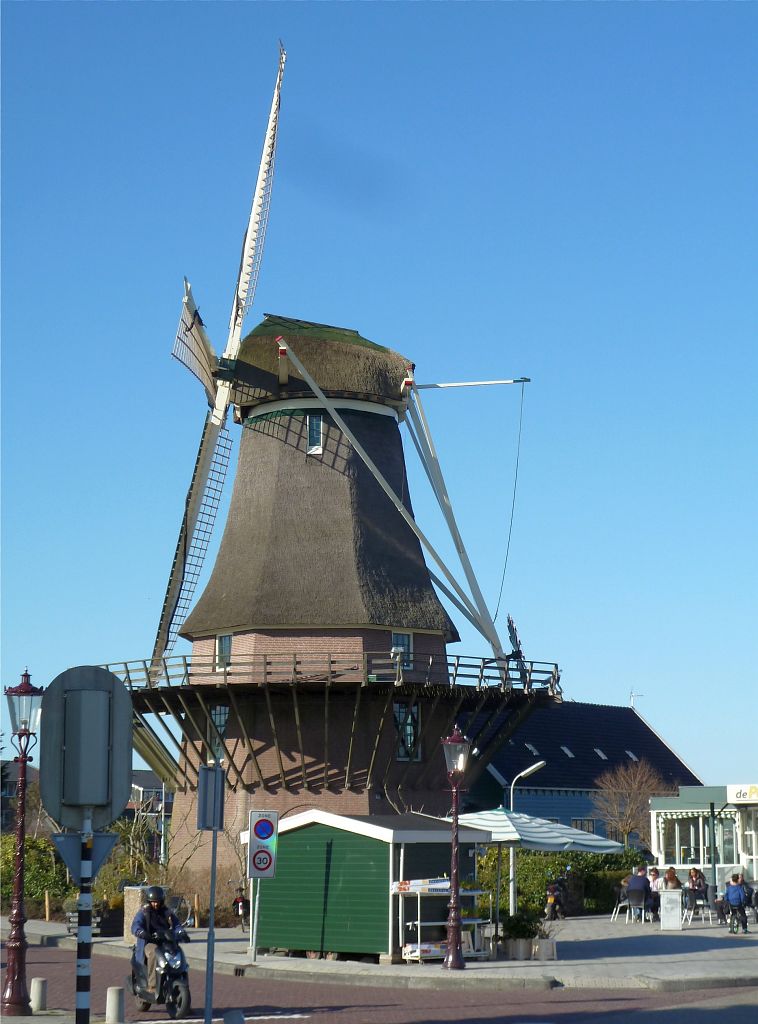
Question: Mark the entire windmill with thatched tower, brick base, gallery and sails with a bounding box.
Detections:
[110,49,560,872]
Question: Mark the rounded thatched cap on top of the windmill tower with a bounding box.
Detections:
[230,313,412,407]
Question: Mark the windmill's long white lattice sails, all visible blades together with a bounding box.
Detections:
[151,46,287,680]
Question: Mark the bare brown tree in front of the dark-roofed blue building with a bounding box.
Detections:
[592,760,675,846]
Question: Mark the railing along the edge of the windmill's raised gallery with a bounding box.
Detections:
[104,652,560,696]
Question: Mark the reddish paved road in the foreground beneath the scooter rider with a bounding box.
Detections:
[3,946,758,1024]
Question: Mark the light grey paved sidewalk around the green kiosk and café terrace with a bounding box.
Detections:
[0,916,758,992]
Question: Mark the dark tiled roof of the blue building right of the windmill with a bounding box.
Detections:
[477,700,702,790]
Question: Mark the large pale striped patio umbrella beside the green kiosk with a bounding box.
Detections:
[459,807,624,930]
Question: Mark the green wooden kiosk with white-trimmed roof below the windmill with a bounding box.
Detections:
[242,809,490,958]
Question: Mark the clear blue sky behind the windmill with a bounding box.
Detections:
[2,3,758,783]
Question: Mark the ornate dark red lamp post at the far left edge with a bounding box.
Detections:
[2,670,44,1017]
